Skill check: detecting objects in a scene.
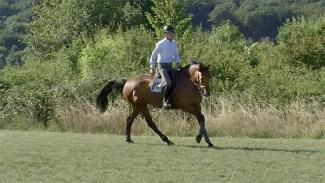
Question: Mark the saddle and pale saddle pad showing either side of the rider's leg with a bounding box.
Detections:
[150,70,178,93]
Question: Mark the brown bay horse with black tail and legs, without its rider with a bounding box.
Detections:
[96,62,214,147]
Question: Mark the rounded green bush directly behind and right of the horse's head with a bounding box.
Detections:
[183,22,251,92]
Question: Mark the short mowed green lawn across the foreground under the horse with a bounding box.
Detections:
[0,131,325,183]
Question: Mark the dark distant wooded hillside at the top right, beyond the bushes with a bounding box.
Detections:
[185,0,325,40]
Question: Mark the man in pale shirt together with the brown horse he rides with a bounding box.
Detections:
[96,25,213,147]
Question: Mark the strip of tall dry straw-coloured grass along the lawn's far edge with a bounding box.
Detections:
[43,96,325,139]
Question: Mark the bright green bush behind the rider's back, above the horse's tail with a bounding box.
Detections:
[79,27,155,86]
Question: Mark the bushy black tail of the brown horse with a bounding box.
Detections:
[96,79,126,112]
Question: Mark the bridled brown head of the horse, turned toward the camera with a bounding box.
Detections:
[189,62,210,97]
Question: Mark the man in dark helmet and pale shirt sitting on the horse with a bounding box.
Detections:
[150,25,180,108]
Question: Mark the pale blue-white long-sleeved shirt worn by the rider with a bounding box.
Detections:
[150,38,180,69]
